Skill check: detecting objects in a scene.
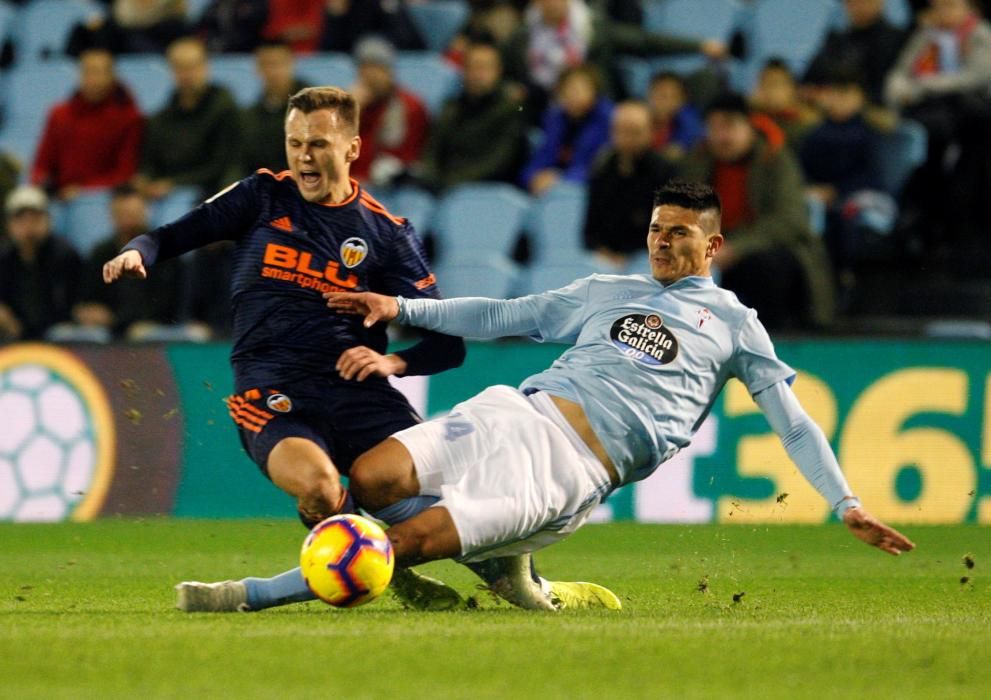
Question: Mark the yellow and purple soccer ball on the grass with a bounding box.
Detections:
[299,515,395,608]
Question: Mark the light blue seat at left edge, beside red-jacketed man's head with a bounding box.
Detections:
[4,59,77,122]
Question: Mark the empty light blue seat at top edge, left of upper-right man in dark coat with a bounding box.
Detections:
[740,0,836,91]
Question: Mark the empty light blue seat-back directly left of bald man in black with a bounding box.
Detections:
[527,183,589,265]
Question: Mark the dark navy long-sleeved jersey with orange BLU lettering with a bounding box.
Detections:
[125,170,464,391]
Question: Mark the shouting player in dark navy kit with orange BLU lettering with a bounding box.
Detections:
[103,87,600,611]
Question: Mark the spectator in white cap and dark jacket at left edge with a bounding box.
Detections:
[0,185,81,341]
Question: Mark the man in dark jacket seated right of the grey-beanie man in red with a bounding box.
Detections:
[420,42,527,189]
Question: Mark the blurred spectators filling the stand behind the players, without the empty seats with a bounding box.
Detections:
[0,0,991,342]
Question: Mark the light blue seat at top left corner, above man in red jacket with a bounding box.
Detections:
[15,0,104,65]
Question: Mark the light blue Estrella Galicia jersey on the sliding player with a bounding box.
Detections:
[399,275,795,483]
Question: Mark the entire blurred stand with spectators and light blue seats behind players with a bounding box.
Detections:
[0,0,991,342]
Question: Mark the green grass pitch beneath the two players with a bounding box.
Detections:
[0,519,991,700]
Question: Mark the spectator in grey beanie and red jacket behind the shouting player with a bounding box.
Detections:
[351,37,429,186]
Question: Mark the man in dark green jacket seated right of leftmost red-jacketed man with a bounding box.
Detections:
[134,37,240,199]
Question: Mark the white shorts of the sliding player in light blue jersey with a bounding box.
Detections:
[393,386,612,561]
